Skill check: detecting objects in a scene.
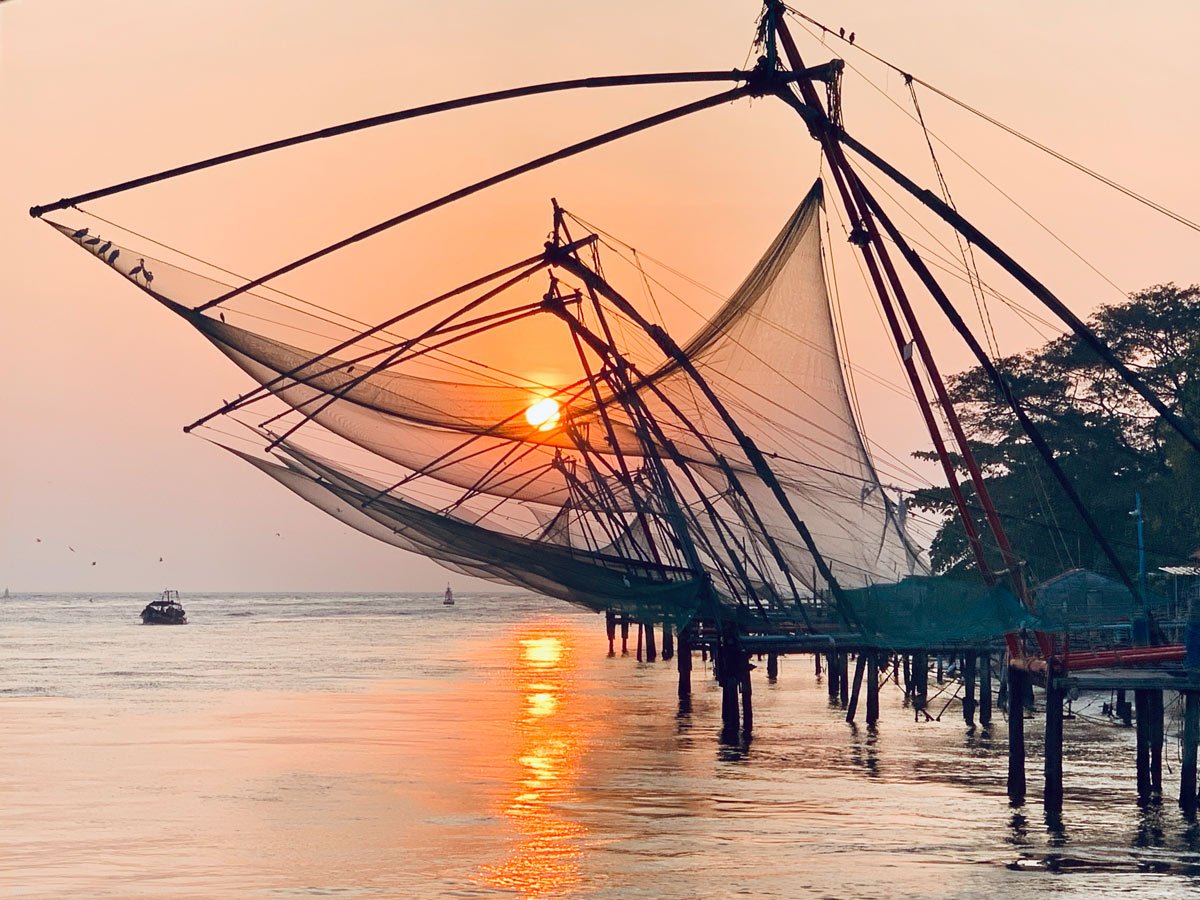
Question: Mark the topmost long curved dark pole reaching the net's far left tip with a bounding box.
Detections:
[29,70,787,218]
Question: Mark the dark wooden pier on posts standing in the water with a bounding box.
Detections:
[606,613,1200,821]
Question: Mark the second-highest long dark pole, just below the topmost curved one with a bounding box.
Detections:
[196,86,754,312]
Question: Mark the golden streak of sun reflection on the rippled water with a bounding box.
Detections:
[482,635,588,898]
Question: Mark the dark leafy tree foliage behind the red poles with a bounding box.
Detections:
[916,284,1200,580]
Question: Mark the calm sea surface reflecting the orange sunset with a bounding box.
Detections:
[0,594,1200,899]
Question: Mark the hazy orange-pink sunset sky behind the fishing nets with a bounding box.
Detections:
[0,0,1200,590]
